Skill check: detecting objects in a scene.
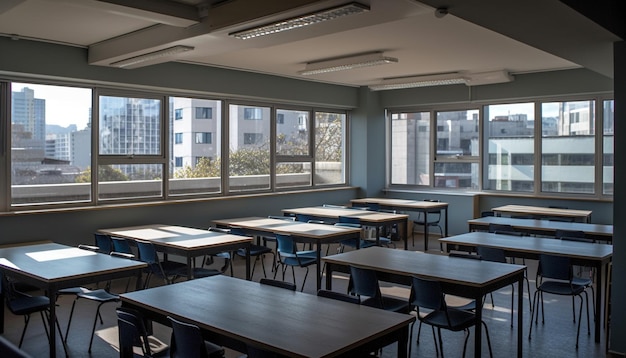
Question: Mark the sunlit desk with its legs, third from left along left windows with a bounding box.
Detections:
[213,216,361,290]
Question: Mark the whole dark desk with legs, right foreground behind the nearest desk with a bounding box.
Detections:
[324,246,525,357]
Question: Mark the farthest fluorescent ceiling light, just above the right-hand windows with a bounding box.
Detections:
[369,71,514,91]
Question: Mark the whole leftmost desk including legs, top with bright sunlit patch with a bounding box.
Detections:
[0,243,146,357]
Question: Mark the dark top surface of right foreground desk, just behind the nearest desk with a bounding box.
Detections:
[322,247,524,287]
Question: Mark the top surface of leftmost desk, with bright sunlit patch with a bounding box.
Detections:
[0,243,146,283]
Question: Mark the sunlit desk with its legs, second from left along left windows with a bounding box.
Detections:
[98,224,252,280]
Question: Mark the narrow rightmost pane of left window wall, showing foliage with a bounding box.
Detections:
[315,112,346,185]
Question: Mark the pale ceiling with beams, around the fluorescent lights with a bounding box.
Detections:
[0,0,619,86]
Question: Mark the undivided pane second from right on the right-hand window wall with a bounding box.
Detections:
[541,101,595,194]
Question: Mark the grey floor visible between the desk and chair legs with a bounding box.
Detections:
[4,237,606,357]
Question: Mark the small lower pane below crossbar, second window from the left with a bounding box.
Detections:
[98,164,163,201]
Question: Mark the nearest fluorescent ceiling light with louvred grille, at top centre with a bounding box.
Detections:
[229,2,369,40]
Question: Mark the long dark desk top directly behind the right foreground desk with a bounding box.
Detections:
[439,231,613,261]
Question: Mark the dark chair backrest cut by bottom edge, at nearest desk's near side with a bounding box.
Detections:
[167,316,209,358]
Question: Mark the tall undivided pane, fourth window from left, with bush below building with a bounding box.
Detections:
[228,104,270,192]
